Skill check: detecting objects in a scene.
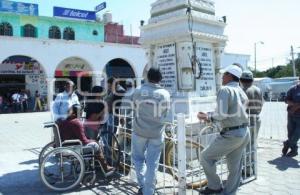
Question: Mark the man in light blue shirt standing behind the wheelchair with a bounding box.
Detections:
[52,81,80,121]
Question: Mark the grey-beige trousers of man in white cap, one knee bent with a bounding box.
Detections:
[200,128,250,195]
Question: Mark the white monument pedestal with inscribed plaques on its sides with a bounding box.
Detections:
[141,0,227,117]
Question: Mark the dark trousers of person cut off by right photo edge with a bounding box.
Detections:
[287,115,300,149]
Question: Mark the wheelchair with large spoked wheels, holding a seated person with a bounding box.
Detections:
[39,122,120,191]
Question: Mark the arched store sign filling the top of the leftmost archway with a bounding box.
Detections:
[0,56,43,75]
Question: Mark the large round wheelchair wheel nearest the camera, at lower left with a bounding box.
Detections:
[40,148,85,191]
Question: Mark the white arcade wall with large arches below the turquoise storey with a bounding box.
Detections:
[0,36,147,104]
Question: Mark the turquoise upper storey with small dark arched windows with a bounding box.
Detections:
[0,12,104,42]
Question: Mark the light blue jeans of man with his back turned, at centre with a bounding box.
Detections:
[131,133,164,195]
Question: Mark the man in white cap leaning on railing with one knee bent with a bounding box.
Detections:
[198,65,250,195]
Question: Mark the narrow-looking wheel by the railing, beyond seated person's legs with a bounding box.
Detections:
[99,131,121,173]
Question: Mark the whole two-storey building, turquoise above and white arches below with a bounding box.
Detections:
[0,13,147,109]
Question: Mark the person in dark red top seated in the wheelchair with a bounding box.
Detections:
[58,103,115,176]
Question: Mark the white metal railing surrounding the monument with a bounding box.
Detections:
[107,109,257,195]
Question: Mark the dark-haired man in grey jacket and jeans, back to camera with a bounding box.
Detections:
[131,68,170,195]
